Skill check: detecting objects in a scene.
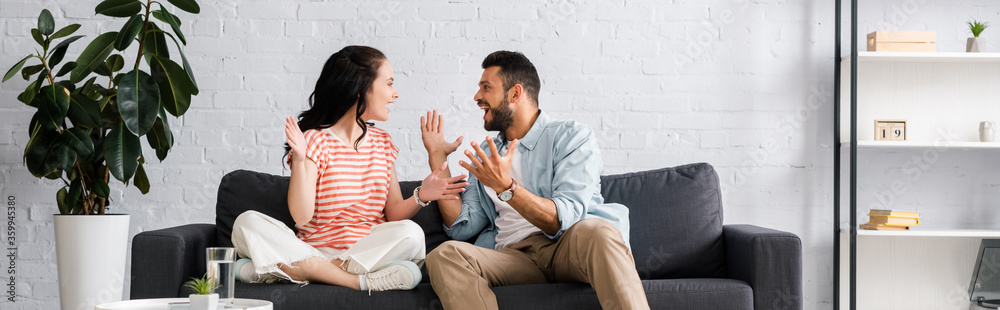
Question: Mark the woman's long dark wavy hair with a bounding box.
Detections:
[285,45,386,160]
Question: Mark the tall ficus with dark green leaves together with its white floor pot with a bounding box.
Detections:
[3,0,200,309]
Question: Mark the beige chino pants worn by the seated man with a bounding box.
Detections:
[426,218,649,309]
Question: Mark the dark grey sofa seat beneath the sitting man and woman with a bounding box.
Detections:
[217,279,753,310]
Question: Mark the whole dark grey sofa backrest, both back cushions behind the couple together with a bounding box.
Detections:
[216,163,725,279]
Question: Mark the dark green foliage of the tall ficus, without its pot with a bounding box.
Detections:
[3,0,200,214]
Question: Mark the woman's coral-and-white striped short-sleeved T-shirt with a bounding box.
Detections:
[295,126,399,250]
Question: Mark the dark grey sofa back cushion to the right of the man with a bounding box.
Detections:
[601,163,726,279]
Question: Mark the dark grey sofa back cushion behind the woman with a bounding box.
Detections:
[215,170,450,253]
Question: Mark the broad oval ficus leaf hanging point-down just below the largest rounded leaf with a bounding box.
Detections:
[104,124,142,182]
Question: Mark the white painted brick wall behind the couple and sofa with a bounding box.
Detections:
[0,0,1000,309]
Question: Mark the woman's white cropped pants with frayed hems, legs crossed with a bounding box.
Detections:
[232,211,427,284]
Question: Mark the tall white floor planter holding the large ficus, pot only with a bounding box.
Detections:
[53,214,129,310]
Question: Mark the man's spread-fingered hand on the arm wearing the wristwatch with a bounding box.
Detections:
[458,137,518,193]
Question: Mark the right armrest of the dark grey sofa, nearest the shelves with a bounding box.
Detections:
[722,225,803,310]
